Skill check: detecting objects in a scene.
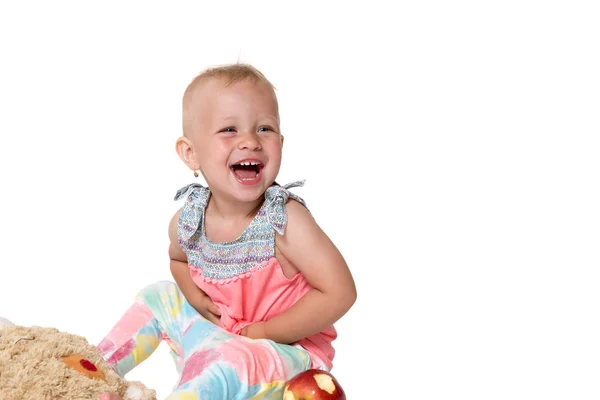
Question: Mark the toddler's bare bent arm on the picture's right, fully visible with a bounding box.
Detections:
[248,201,356,343]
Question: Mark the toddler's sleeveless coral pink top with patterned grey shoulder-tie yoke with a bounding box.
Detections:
[175,182,337,370]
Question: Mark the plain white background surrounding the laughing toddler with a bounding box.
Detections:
[0,1,600,400]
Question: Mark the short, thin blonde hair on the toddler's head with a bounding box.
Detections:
[182,64,277,136]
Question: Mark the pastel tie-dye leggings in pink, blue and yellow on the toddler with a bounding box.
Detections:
[98,282,311,400]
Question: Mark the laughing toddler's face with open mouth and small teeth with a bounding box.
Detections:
[191,80,283,201]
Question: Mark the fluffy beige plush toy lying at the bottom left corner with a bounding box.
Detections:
[0,318,156,400]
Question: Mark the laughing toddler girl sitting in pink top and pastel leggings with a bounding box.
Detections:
[98,64,356,400]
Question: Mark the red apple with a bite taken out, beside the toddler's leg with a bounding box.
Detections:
[283,369,346,400]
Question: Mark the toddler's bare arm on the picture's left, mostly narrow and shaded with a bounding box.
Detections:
[169,210,221,325]
